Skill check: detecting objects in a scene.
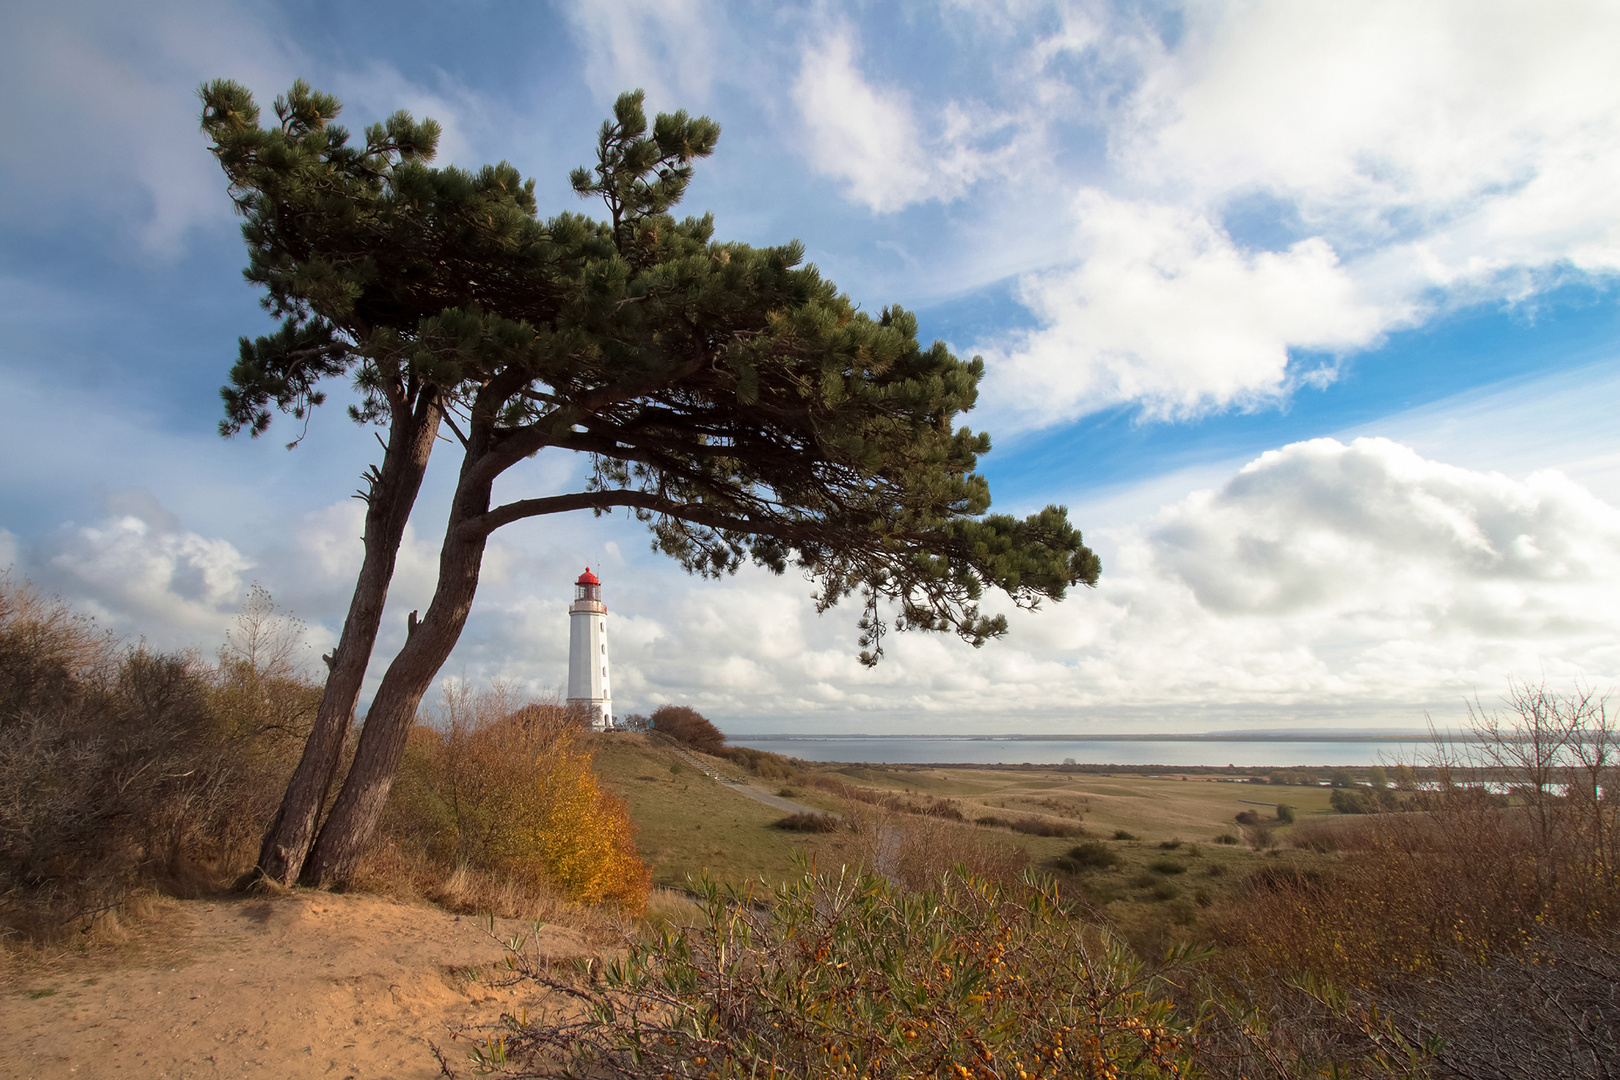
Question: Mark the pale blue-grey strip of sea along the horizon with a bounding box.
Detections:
[726,735,1464,769]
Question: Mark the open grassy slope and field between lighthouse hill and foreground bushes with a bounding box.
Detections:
[598,733,1346,938]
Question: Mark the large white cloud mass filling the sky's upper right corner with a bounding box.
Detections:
[985,0,1620,426]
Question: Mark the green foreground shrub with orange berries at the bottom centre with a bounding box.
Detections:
[478,874,1191,1080]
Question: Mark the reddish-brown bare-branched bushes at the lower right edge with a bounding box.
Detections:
[1217,682,1620,1077]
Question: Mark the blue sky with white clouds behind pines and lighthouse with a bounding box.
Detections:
[0,0,1620,733]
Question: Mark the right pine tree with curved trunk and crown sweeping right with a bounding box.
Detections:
[196,84,1098,884]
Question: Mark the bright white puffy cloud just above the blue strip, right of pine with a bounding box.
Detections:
[990,189,1396,423]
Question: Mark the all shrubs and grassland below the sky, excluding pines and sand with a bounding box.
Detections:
[0,580,1620,1080]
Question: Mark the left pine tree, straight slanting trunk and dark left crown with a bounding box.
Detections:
[199,79,599,884]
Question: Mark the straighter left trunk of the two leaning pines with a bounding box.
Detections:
[246,390,442,886]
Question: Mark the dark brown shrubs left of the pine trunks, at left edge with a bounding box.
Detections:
[0,575,319,938]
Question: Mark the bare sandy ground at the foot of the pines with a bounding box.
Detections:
[0,892,595,1080]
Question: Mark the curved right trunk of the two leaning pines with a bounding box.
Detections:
[300,455,492,886]
